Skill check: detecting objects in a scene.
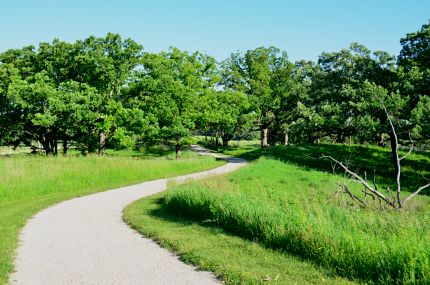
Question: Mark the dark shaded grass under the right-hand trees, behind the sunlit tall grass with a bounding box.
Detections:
[203,144,430,195]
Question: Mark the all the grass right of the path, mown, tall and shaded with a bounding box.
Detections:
[125,145,430,284]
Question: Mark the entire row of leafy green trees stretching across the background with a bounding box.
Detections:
[0,23,430,154]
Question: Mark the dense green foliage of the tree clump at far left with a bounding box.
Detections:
[0,34,141,154]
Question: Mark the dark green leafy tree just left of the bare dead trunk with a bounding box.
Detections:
[296,43,396,143]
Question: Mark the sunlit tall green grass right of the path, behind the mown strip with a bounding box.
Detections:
[164,155,430,284]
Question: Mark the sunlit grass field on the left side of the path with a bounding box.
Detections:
[0,150,221,284]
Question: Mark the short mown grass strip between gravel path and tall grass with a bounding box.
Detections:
[124,193,355,285]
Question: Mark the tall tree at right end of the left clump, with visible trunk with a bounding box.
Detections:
[73,33,142,154]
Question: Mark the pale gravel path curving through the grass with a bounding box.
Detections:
[10,146,246,285]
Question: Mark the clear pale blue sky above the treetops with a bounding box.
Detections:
[0,0,430,61]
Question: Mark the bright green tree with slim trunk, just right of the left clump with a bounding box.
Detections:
[129,48,216,157]
